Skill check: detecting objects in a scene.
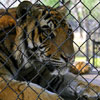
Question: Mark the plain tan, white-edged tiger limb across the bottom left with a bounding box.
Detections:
[0,76,63,100]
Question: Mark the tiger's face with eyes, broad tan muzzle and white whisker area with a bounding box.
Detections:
[37,11,74,66]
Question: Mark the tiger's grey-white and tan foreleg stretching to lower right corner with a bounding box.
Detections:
[58,73,100,100]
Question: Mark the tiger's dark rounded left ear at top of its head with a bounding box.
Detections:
[16,1,32,20]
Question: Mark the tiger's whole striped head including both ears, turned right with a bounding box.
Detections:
[16,1,74,71]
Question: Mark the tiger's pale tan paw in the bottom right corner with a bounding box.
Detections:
[76,82,100,100]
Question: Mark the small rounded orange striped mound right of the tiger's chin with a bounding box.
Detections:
[69,61,93,75]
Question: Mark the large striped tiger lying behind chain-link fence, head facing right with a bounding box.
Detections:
[0,1,100,100]
